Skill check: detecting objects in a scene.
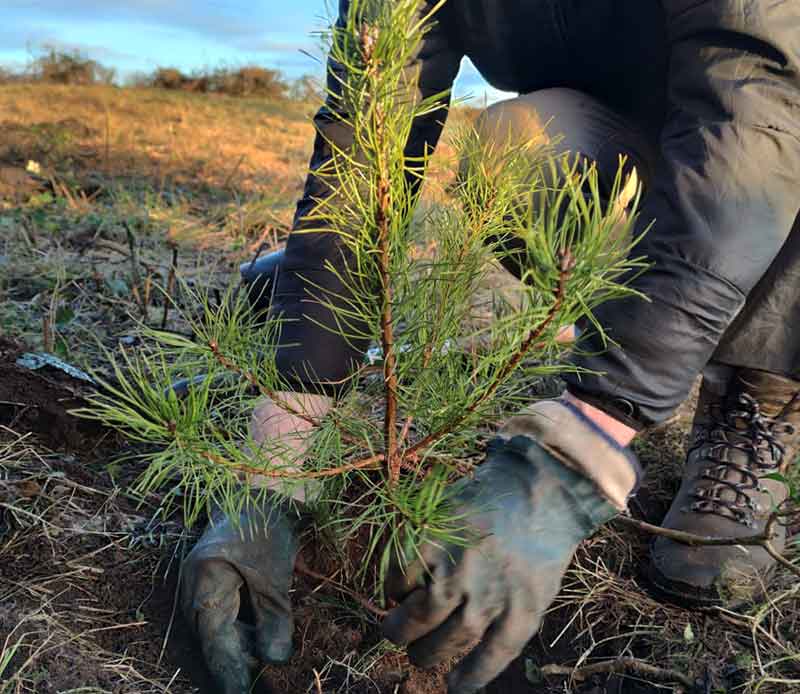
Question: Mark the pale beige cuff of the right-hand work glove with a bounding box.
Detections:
[498,400,642,511]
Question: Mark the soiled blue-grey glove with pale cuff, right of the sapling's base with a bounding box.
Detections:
[383,400,639,694]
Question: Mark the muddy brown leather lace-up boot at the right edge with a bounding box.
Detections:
[650,369,800,604]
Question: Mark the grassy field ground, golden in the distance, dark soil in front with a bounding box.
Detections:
[0,84,800,694]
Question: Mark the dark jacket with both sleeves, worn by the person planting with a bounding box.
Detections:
[276,0,800,423]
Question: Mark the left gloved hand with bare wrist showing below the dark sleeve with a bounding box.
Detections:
[181,393,332,694]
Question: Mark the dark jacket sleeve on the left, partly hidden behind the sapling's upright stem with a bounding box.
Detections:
[272,0,462,392]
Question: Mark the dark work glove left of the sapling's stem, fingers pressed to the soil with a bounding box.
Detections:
[181,502,298,694]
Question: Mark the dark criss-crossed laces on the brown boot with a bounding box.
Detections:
[690,393,795,527]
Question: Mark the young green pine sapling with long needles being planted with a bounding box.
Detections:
[76,0,644,600]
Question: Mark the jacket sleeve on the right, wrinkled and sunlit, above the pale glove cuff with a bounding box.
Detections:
[568,0,800,425]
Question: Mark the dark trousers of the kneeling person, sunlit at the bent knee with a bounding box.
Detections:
[478,88,800,384]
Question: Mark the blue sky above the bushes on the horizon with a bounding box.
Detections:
[0,0,512,101]
